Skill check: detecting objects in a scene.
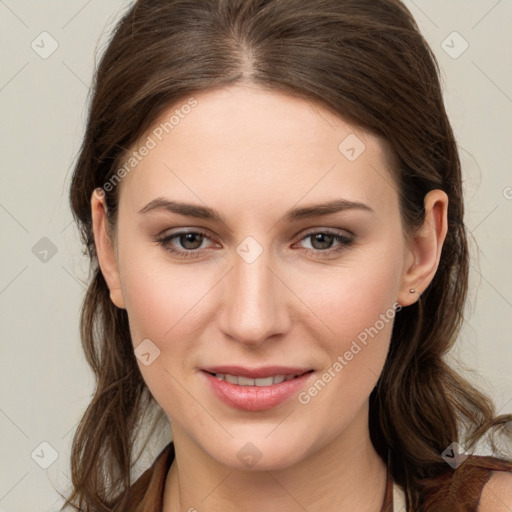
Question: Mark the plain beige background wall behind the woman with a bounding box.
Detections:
[0,0,512,512]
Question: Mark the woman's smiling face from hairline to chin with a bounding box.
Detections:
[93,86,440,469]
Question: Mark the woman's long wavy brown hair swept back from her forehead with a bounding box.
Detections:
[64,0,512,511]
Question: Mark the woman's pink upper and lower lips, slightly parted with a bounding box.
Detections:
[201,366,313,411]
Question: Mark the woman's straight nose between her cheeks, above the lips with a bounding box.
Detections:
[217,245,293,347]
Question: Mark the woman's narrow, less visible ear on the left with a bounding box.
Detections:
[91,188,126,309]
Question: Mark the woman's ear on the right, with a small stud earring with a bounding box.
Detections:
[397,190,448,306]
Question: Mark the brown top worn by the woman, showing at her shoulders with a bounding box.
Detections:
[129,441,512,512]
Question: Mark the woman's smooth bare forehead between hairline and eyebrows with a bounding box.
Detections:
[121,85,396,218]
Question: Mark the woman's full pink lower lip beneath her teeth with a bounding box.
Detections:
[202,371,313,411]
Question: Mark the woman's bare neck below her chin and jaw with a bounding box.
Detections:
[163,403,387,512]
